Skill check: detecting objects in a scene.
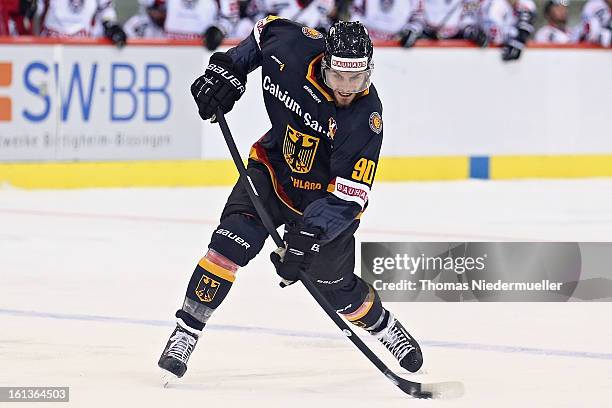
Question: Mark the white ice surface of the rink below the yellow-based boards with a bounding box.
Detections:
[0,180,612,408]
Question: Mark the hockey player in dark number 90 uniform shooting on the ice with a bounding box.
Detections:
[158,16,423,377]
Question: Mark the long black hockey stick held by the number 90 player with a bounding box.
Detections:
[216,109,463,398]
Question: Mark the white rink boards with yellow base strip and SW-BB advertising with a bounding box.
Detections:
[0,39,612,188]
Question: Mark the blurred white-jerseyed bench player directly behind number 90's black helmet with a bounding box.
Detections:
[350,0,425,48]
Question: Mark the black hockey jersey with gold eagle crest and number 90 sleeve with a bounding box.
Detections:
[228,16,383,240]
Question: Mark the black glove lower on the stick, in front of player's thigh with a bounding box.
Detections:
[270,223,320,287]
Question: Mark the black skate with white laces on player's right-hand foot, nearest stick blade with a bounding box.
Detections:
[372,311,423,373]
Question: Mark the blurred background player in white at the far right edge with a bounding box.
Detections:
[581,0,612,48]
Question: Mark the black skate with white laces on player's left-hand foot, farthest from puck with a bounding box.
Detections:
[157,324,201,385]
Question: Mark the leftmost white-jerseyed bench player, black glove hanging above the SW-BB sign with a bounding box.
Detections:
[38,0,126,47]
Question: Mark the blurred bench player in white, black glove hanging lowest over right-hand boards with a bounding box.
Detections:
[482,0,536,61]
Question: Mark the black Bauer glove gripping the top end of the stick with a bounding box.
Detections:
[191,52,246,120]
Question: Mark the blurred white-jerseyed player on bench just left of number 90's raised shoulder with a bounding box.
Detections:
[164,0,238,51]
